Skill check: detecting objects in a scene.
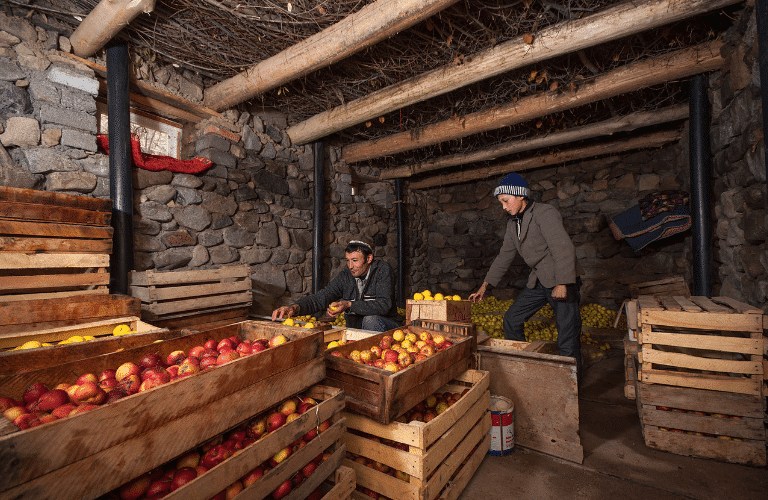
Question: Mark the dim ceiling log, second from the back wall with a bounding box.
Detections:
[381,104,688,179]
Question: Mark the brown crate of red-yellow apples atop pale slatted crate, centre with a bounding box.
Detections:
[325,327,472,424]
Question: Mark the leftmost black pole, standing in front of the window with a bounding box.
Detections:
[107,44,133,295]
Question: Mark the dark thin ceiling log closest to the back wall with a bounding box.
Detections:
[408,130,682,189]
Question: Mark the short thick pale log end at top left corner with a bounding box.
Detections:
[69,0,155,57]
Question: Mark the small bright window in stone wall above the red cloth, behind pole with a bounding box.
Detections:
[96,99,182,158]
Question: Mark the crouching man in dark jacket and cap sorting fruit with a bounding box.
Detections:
[272,238,402,332]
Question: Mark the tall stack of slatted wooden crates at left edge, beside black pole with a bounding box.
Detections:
[0,186,113,301]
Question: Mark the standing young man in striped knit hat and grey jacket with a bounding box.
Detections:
[469,173,581,381]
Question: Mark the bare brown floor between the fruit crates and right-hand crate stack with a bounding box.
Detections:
[459,349,768,500]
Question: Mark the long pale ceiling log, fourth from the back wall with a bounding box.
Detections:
[287,0,738,144]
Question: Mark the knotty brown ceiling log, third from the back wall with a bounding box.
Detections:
[341,40,723,163]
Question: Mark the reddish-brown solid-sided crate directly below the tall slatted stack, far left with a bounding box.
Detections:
[0,294,141,336]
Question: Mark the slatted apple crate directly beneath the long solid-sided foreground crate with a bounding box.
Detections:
[101,385,354,500]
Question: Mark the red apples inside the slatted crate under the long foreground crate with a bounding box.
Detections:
[112,396,331,500]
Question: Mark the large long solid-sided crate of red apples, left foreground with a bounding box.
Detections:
[0,322,325,499]
